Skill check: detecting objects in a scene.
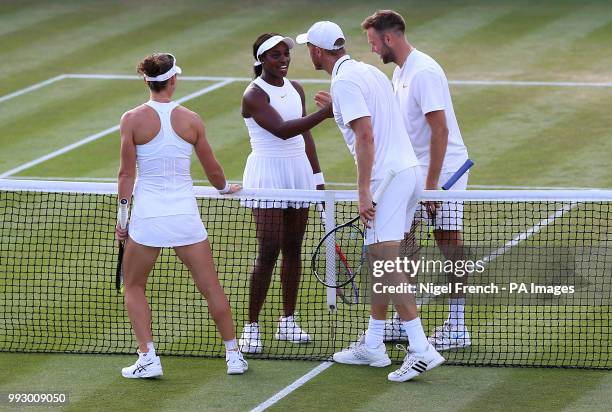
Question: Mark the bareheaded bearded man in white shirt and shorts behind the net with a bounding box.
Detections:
[361,10,471,350]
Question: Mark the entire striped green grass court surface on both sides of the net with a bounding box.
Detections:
[0,0,612,410]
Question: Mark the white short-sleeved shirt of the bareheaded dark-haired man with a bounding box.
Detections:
[393,49,468,172]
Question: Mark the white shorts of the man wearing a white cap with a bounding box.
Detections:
[365,166,424,245]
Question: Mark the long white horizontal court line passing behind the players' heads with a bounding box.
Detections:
[64,73,612,88]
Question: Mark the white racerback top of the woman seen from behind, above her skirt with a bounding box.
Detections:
[132,100,199,218]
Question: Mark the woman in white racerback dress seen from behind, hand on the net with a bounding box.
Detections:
[116,53,248,378]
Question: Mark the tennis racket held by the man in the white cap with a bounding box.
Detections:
[312,171,396,288]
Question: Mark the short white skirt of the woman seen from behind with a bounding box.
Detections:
[128,214,208,247]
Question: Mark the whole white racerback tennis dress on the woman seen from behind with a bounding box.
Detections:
[128,100,208,247]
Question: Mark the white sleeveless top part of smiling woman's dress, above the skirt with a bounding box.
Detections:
[244,77,306,157]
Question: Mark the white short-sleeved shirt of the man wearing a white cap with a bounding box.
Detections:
[331,55,419,181]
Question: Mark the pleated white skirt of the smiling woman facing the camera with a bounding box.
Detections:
[240,153,316,209]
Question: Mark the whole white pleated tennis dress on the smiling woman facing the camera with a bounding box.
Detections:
[242,77,316,208]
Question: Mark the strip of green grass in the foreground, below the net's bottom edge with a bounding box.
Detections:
[0,353,612,411]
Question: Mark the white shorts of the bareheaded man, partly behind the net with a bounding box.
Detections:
[414,167,468,232]
